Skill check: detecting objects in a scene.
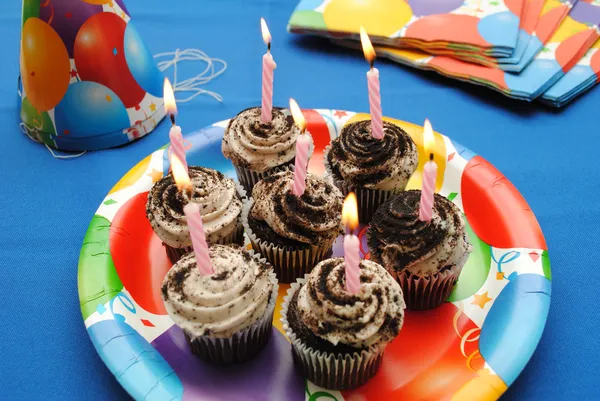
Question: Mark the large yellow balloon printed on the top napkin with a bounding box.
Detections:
[323,0,412,37]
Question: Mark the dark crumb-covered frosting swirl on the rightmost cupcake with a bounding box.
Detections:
[368,190,472,277]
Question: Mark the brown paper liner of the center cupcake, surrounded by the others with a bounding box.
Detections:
[242,199,335,284]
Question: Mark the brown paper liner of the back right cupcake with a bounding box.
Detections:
[323,145,404,224]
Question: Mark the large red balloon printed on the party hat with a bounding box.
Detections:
[75,12,146,108]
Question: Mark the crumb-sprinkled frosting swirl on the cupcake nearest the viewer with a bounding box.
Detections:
[298,258,406,348]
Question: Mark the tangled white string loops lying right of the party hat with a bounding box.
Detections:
[154,49,227,103]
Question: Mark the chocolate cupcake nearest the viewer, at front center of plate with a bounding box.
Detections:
[281,258,405,390]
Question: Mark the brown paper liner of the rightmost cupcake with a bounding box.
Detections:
[396,266,462,310]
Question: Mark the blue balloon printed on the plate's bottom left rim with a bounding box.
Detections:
[88,320,183,401]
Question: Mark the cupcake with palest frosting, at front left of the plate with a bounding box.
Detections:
[161,245,278,365]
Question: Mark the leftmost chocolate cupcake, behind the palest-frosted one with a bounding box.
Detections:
[146,166,245,263]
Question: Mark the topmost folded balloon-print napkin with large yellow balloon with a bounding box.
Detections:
[288,0,526,57]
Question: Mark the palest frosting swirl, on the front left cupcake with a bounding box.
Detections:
[161,245,275,337]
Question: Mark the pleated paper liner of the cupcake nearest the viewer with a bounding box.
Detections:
[281,276,385,390]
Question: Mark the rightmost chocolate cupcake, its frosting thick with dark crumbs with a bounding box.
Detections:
[367,190,472,309]
